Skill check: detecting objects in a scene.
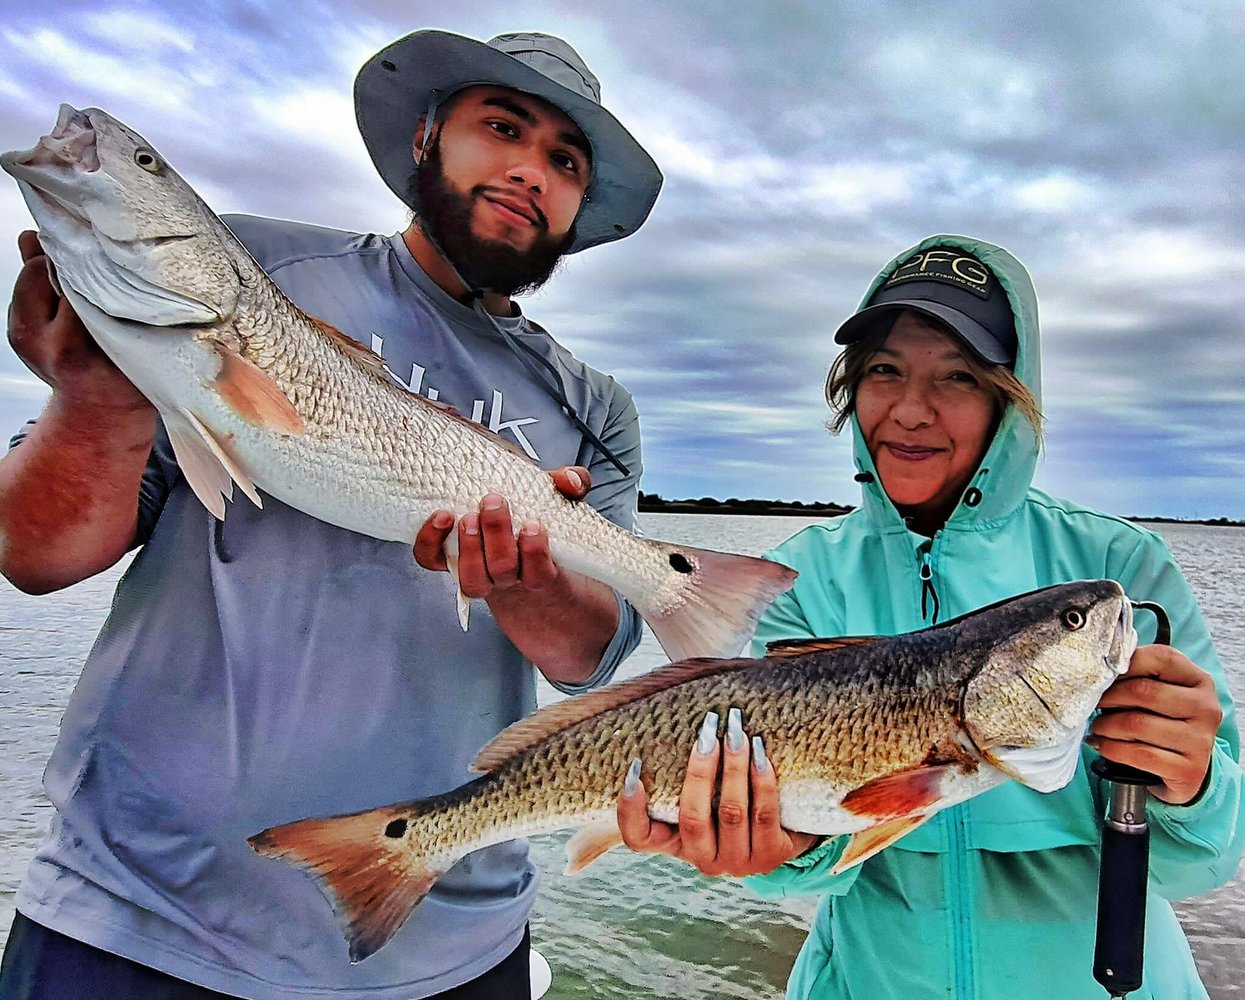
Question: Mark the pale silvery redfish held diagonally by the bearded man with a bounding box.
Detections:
[0,105,796,659]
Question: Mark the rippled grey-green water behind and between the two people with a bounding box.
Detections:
[0,514,1245,1000]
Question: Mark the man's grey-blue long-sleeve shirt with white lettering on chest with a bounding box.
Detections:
[17,217,640,1000]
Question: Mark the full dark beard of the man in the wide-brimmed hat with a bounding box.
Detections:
[408,140,575,296]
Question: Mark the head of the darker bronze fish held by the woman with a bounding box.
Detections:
[961,580,1137,792]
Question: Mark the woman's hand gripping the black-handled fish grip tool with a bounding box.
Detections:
[1088,645,1224,806]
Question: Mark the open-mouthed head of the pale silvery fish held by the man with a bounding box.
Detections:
[0,105,242,326]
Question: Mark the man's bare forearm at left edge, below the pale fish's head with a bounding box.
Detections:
[0,395,156,593]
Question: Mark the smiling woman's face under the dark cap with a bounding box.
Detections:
[855,310,998,534]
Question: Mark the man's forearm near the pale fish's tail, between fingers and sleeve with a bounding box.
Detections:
[488,570,619,684]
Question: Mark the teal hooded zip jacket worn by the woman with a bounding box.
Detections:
[746,235,1245,1000]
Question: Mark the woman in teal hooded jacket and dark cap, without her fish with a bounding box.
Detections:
[619,235,1245,1000]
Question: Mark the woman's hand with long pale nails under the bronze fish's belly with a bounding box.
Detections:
[618,709,817,877]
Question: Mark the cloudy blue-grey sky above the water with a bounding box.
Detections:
[0,0,1245,518]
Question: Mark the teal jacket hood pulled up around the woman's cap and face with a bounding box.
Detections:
[852,233,1042,531]
